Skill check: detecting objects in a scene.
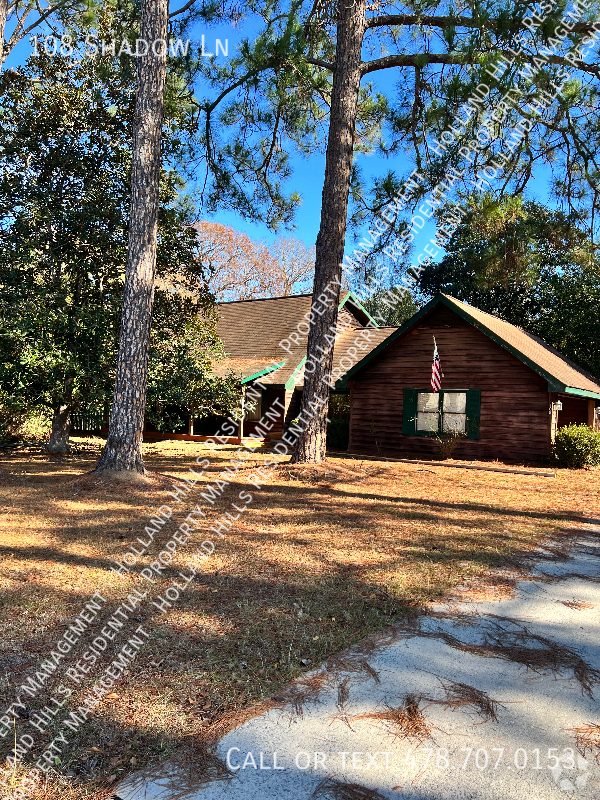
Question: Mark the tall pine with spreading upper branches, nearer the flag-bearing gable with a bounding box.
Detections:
[195,0,600,461]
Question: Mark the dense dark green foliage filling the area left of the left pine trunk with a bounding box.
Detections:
[0,55,131,422]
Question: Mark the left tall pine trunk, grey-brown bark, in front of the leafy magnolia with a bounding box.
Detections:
[95,0,168,475]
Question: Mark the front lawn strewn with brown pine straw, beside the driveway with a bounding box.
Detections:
[0,438,600,800]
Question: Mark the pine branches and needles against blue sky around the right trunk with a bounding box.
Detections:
[151,0,600,252]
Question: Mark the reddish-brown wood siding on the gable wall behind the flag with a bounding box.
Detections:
[349,306,550,461]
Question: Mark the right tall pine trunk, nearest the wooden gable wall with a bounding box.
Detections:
[292,0,366,462]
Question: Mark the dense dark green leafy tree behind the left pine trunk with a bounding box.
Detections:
[0,47,236,452]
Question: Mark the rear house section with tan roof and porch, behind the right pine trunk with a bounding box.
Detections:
[204,291,396,440]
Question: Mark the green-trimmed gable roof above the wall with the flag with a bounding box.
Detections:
[344,294,600,400]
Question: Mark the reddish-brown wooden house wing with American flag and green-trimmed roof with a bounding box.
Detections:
[336,294,600,461]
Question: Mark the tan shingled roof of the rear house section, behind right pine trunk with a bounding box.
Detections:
[214,291,381,389]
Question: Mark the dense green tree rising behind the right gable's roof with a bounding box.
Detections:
[417,196,600,376]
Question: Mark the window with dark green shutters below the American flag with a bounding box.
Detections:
[402,389,481,439]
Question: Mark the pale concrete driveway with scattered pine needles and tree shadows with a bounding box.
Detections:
[115,520,600,800]
